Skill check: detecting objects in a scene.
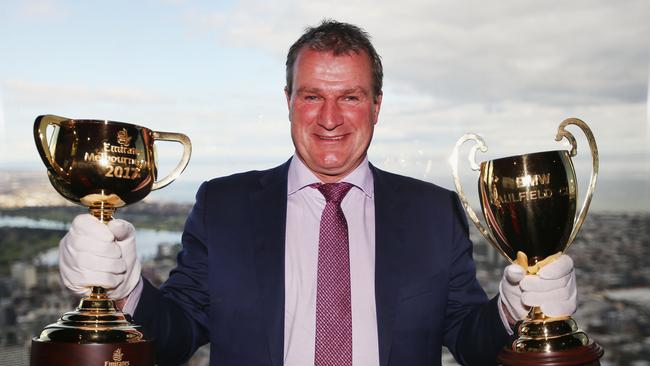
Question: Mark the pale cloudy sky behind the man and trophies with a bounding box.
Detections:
[0,0,650,211]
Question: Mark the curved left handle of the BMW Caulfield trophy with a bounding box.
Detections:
[449,133,512,261]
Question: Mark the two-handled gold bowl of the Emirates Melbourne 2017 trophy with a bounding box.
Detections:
[34,115,191,217]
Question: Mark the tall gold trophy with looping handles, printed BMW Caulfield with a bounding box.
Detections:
[450,118,603,366]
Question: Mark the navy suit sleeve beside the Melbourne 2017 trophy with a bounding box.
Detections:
[134,183,210,365]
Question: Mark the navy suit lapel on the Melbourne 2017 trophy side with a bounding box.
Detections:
[251,162,289,366]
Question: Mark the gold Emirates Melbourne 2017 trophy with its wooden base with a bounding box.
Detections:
[30,115,192,366]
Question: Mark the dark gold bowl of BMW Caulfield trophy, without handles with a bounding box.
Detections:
[478,150,577,265]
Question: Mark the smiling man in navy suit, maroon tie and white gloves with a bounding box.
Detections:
[61,21,575,366]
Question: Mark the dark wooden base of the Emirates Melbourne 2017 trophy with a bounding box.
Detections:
[29,338,154,366]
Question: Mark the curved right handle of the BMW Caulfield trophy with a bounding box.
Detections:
[555,118,598,251]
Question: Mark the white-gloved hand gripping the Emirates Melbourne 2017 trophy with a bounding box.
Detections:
[59,214,141,300]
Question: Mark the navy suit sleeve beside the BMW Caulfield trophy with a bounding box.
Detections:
[444,193,510,366]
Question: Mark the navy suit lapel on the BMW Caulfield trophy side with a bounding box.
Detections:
[370,165,404,366]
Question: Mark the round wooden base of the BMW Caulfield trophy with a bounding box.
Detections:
[497,343,604,366]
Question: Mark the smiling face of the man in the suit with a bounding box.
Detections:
[285,48,382,183]
